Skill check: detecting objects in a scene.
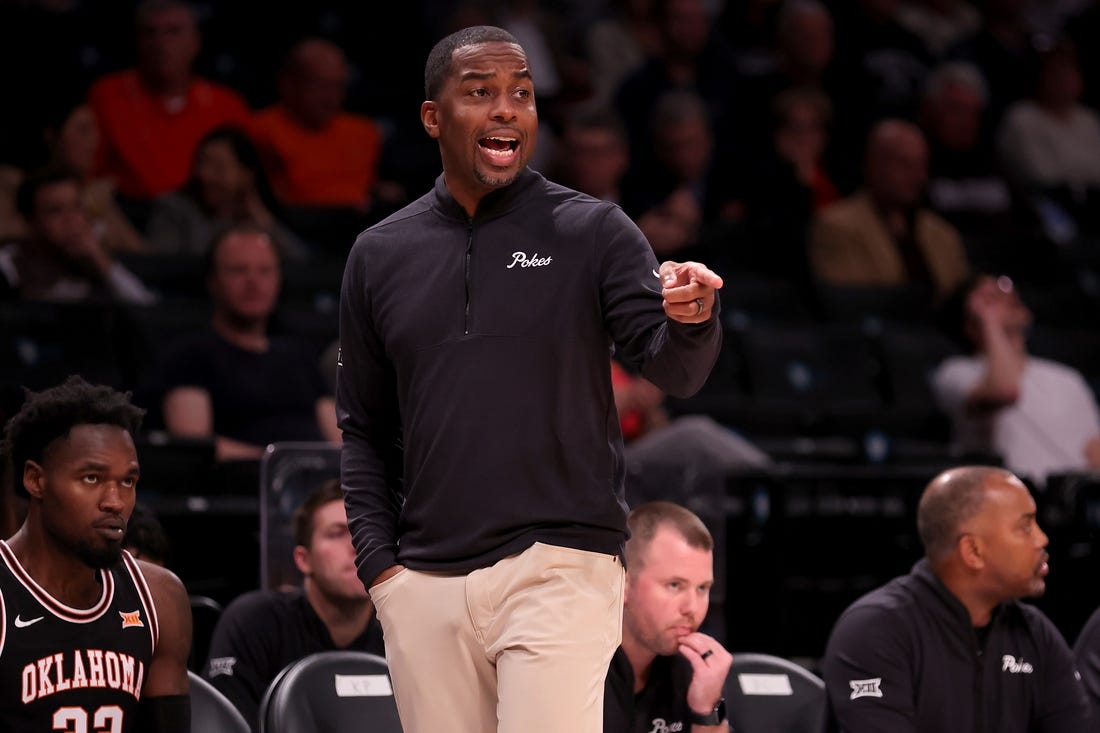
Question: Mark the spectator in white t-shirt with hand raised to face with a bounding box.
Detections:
[933,274,1100,484]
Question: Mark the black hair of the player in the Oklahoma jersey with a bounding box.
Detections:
[0,374,145,488]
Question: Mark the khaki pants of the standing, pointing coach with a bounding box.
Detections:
[364,543,624,733]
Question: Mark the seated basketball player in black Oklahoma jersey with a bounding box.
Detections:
[0,376,191,733]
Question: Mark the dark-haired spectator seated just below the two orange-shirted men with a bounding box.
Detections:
[147,125,309,260]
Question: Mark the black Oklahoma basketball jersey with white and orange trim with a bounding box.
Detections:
[0,540,157,733]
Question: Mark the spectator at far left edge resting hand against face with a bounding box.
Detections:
[0,166,157,305]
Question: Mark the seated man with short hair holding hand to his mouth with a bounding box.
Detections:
[604,502,733,733]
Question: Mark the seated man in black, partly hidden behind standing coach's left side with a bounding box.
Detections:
[205,480,385,730]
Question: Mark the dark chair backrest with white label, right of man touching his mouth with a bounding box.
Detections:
[726,653,826,733]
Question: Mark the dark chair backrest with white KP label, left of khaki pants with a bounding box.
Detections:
[260,650,402,733]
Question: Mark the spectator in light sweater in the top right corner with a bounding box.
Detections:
[997,41,1100,239]
